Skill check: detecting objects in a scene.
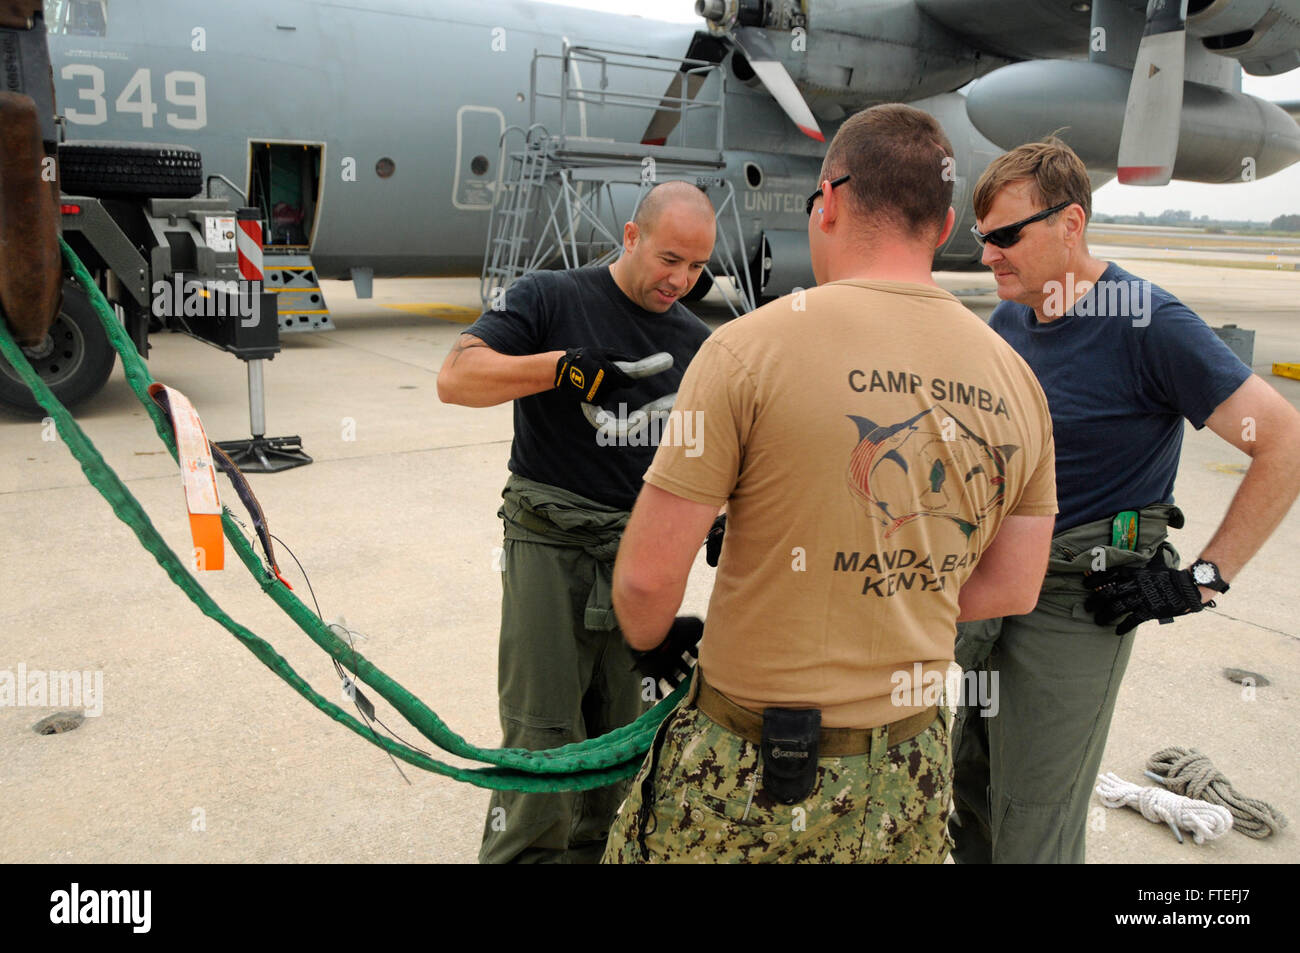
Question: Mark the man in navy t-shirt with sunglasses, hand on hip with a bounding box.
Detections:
[952,139,1300,863]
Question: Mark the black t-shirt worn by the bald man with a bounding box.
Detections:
[465,267,709,510]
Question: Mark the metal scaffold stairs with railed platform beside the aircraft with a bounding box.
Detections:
[480,44,755,315]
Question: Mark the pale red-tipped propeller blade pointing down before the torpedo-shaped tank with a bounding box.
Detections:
[1118,0,1187,186]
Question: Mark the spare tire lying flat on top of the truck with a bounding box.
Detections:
[59,142,203,199]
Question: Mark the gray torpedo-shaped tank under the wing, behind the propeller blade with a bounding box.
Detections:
[966,60,1300,182]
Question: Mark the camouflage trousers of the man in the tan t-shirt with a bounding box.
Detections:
[601,705,952,863]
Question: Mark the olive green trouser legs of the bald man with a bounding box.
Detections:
[478,540,646,863]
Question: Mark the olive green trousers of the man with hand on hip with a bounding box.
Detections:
[949,506,1183,863]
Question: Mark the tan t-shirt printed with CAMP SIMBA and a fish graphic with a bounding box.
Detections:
[645,281,1056,727]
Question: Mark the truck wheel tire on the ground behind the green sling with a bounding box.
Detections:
[0,281,117,417]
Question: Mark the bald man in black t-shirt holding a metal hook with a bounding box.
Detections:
[438,182,715,863]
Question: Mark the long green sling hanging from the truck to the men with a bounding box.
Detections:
[0,239,689,792]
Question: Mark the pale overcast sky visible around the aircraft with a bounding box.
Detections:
[550,0,1300,221]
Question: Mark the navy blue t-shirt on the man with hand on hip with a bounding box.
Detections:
[989,263,1251,533]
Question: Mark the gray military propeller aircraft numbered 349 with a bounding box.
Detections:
[17,0,1300,405]
